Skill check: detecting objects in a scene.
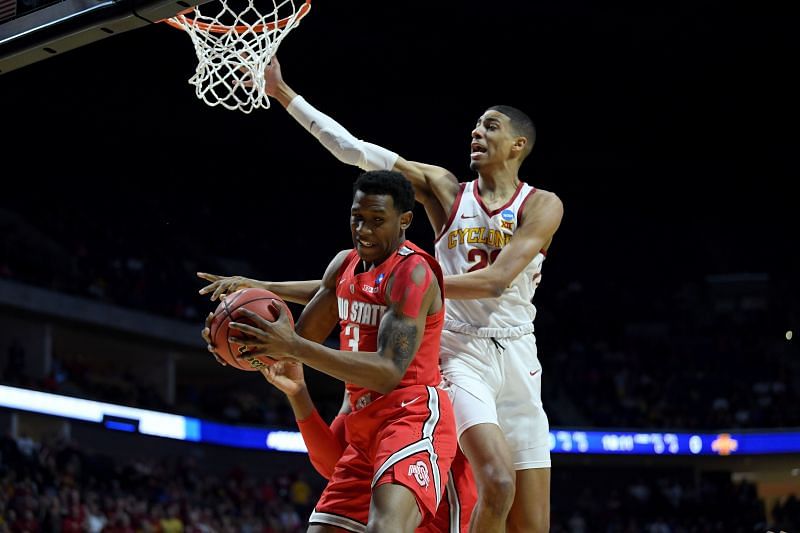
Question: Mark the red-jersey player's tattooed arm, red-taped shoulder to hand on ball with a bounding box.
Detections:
[230,256,441,393]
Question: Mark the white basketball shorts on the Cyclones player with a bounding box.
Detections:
[441,330,550,470]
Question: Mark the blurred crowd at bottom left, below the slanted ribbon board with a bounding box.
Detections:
[0,430,318,533]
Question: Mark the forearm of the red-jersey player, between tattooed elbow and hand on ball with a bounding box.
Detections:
[292,336,403,393]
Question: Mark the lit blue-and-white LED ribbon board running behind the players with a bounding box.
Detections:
[0,385,800,457]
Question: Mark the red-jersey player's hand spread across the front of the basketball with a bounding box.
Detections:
[228,303,296,360]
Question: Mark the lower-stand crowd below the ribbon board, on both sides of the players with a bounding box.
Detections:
[0,430,800,533]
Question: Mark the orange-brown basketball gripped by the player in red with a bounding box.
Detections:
[209,288,294,371]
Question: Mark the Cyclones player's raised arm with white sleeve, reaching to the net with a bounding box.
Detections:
[264,57,459,233]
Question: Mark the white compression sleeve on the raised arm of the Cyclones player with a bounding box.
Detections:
[286,95,399,170]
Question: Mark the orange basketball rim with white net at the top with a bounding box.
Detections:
[162,0,311,113]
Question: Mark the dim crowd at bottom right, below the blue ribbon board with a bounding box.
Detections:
[551,466,800,533]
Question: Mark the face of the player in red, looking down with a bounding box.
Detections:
[350,191,411,264]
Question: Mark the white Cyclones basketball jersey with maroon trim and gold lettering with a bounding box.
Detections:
[434,180,544,338]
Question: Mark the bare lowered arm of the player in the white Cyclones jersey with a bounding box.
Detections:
[444,190,564,300]
